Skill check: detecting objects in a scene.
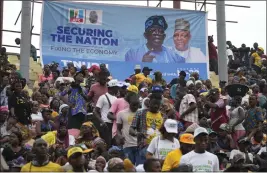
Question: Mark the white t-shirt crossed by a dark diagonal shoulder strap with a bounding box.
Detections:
[96,93,117,123]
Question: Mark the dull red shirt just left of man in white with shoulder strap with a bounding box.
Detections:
[88,82,108,106]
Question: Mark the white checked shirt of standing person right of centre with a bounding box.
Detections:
[179,94,198,123]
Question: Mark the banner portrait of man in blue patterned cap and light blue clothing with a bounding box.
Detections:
[125,16,184,63]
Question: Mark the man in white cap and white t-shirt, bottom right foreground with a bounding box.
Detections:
[180,127,219,172]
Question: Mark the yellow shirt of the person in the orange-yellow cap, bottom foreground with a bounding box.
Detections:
[162,149,183,171]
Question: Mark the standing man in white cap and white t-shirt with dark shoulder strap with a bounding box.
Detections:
[94,79,119,146]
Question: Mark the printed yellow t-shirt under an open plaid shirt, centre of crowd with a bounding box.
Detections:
[146,111,163,144]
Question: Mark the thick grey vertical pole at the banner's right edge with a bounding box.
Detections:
[216,0,228,82]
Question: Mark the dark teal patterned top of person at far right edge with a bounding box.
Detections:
[244,107,263,130]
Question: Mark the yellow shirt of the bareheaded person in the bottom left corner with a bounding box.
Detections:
[20,162,63,172]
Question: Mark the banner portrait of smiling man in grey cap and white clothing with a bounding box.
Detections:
[173,18,207,63]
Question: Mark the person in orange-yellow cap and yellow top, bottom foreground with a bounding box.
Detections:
[162,133,195,171]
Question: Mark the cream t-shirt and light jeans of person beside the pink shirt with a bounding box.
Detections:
[117,109,137,148]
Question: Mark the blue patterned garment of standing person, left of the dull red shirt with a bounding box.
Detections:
[69,87,87,115]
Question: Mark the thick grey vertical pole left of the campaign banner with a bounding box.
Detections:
[20,1,31,81]
